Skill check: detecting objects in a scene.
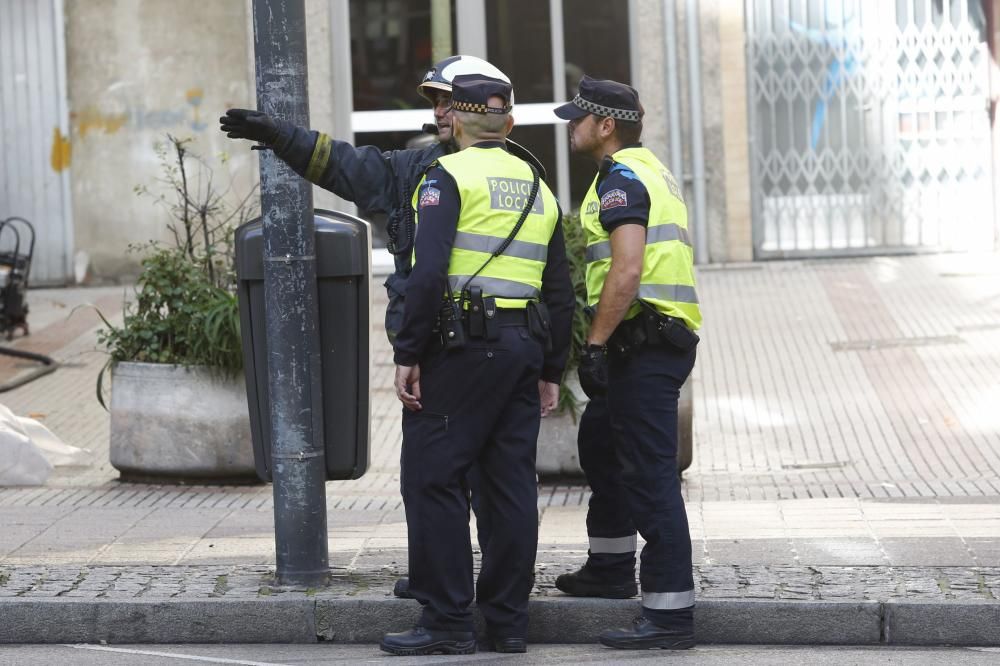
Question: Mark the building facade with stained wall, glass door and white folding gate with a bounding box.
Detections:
[0,0,1000,284]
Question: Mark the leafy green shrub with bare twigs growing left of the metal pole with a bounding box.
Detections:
[97,135,256,405]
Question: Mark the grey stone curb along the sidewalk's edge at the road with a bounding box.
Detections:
[0,597,1000,645]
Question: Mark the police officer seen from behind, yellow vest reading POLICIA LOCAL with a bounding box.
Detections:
[380,75,574,655]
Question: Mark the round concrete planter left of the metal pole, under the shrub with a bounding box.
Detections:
[110,363,257,483]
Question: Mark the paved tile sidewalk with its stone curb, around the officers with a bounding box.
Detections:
[0,255,1000,644]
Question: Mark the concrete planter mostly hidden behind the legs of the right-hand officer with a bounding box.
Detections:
[535,377,694,478]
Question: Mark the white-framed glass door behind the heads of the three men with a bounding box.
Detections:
[332,0,631,223]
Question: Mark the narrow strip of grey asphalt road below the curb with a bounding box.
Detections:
[0,644,1000,666]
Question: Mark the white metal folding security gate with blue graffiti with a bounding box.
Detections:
[746,0,997,258]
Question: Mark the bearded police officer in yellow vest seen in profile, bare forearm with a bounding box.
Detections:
[556,76,701,649]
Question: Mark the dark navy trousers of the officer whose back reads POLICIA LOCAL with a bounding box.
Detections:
[402,326,542,638]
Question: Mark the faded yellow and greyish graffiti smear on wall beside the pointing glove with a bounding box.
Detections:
[70,88,208,138]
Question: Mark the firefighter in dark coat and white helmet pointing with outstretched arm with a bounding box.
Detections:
[219,55,544,597]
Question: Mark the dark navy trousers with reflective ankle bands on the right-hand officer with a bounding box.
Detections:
[578,346,695,621]
